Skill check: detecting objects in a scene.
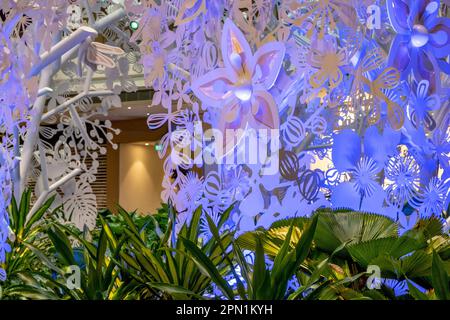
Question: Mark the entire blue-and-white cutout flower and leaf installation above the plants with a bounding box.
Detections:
[0,0,450,279]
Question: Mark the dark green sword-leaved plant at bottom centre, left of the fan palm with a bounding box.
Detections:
[183,212,317,300]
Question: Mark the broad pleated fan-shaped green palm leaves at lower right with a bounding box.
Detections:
[238,210,450,299]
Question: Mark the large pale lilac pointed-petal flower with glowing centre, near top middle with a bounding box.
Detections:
[192,20,285,138]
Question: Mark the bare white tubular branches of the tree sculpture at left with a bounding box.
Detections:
[8,5,126,228]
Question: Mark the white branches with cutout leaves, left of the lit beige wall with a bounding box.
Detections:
[0,0,135,278]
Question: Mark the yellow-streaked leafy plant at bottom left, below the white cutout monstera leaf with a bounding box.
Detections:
[38,217,141,300]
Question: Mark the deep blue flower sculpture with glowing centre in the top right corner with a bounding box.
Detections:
[386,0,450,90]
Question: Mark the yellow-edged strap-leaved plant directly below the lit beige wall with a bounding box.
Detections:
[119,207,236,299]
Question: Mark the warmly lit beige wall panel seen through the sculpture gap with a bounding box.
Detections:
[119,143,163,214]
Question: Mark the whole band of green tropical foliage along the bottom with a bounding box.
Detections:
[1,199,450,300]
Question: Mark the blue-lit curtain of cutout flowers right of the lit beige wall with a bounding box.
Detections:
[135,0,450,236]
